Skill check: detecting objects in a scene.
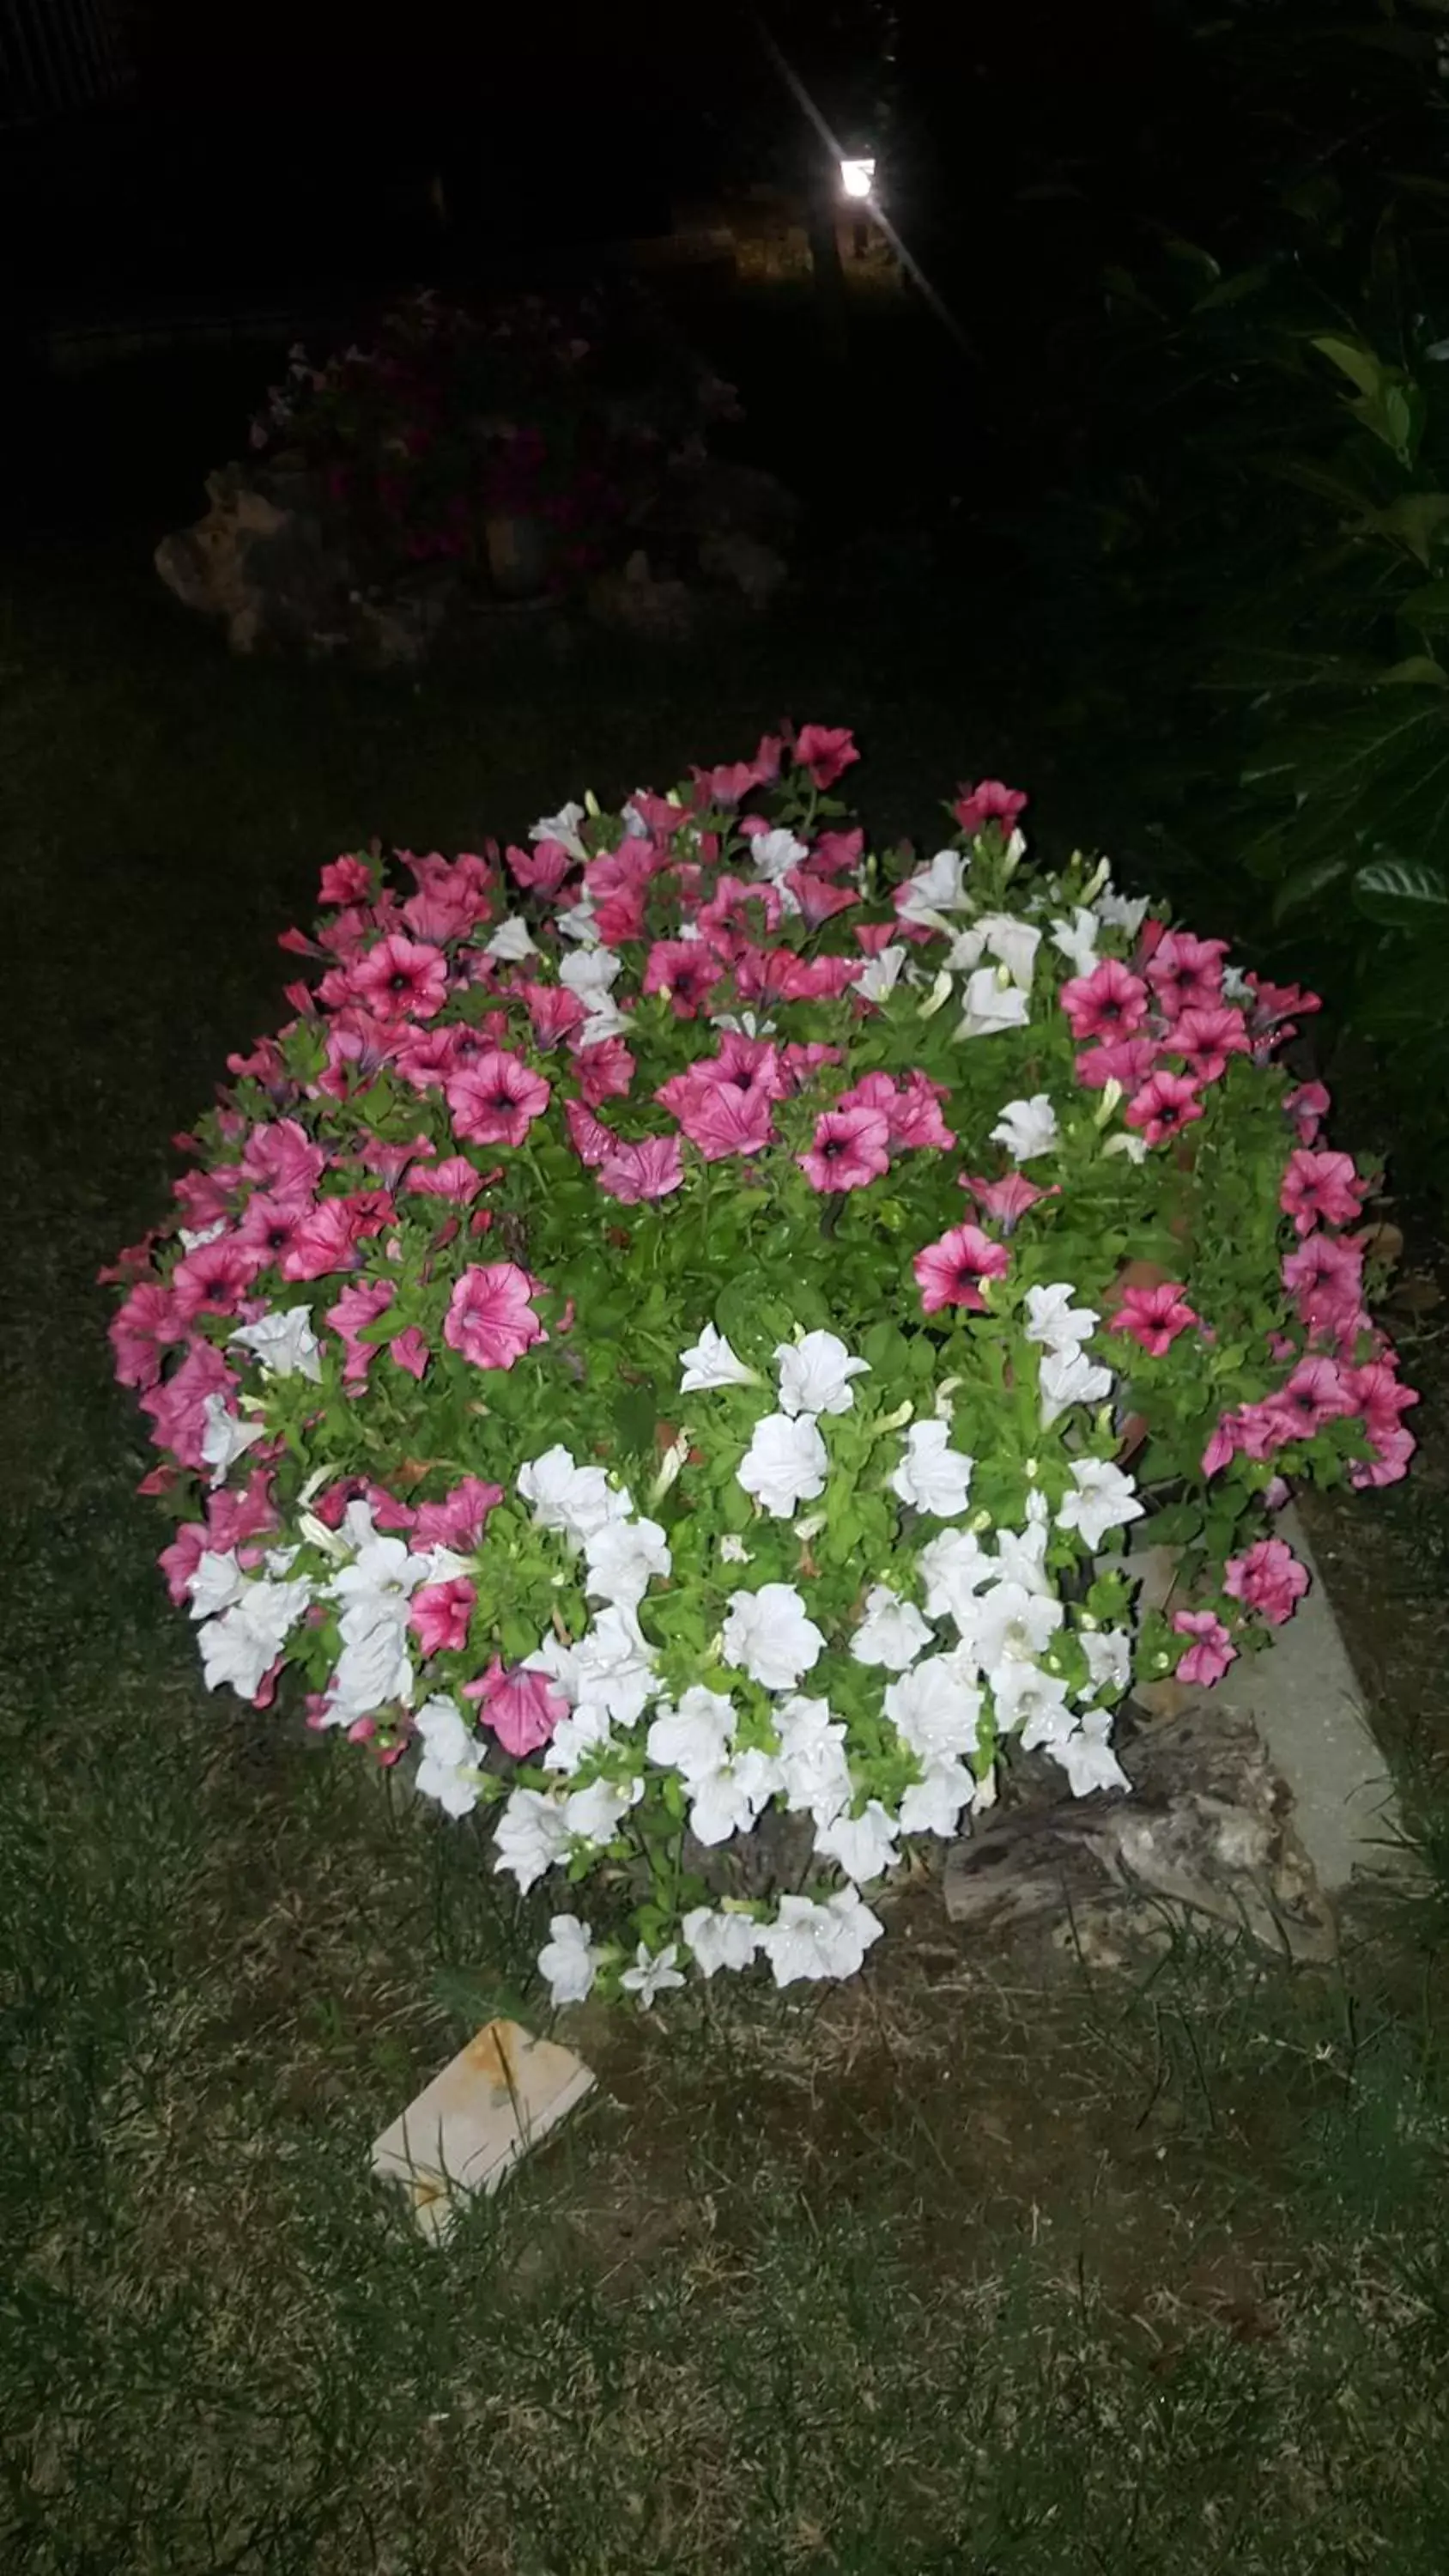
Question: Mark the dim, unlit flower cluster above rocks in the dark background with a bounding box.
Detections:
[252,283,736,590]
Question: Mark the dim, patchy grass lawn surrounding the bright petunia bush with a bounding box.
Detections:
[0,386,1449,2576]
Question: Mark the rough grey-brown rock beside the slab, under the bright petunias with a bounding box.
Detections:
[944,1703,1336,1960]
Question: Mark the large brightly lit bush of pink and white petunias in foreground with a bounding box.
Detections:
[108,726,1416,2004]
